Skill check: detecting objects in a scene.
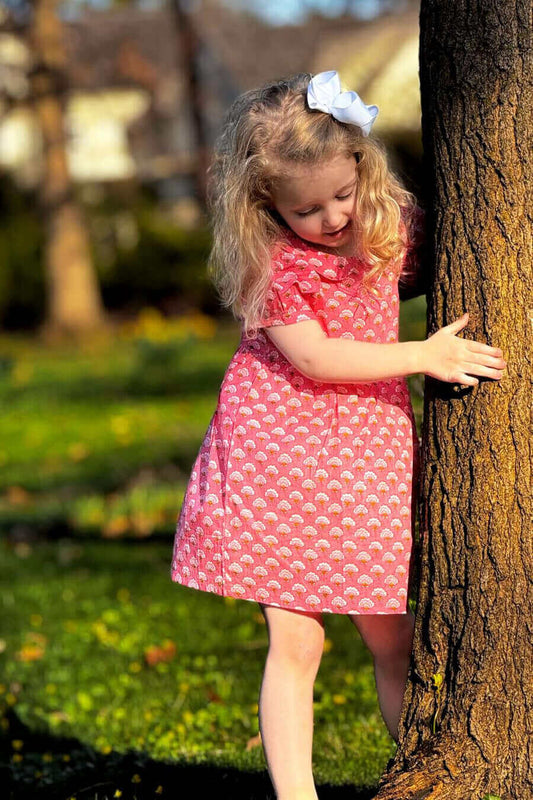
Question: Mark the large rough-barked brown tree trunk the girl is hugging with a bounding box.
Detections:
[377,0,533,800]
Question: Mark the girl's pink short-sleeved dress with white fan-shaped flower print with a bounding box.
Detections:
[171,228,417,614]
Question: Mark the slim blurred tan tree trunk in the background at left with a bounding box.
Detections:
[31,0,105,336]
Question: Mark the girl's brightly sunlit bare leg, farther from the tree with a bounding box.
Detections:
[259,606,324,800]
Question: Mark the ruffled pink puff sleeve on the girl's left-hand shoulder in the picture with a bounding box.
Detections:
[260,248,321,328]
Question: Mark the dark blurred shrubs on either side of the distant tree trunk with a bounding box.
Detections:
[0,175,220,330]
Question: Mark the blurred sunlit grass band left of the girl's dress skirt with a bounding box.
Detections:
[0,318,238,537]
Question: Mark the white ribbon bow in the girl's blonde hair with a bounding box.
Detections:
[307,70,378,136]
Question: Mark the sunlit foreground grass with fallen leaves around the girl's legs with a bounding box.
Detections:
[0,540,393,796]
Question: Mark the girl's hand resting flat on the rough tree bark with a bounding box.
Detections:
[420,314,506,386]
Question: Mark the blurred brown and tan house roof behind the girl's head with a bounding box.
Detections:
[0,0,420,130]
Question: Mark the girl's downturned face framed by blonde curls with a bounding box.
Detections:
[272,155,357,255]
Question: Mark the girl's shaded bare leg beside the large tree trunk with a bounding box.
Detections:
[351,611,415,741]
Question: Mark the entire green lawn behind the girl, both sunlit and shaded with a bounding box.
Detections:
[0,301,424,800]
